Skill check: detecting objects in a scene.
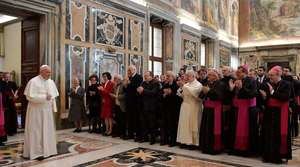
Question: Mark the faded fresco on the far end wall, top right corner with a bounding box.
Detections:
[250,0,300,40]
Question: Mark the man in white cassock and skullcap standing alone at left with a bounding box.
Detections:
[23,65,59,160]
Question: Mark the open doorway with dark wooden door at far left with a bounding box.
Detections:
[0,6,41,128]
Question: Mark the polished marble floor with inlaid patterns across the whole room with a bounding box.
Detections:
[0,129,300,167]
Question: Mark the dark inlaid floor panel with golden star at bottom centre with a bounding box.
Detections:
[75,148,239,167]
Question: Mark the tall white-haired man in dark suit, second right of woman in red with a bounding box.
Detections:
[124,66,143,139]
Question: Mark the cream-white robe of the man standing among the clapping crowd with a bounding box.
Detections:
[177,79,202,145]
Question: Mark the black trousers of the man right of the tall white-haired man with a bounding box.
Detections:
[139,111,156,139]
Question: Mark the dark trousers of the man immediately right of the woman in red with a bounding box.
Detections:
[113,105,126,136]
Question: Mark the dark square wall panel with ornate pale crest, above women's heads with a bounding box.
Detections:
[95,10,125,48]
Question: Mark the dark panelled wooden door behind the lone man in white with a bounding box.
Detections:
[21,16,40,85]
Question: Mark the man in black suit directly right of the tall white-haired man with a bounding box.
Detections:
[137,71,160,144]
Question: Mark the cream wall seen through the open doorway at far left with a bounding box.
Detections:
[3,22,21,85]
